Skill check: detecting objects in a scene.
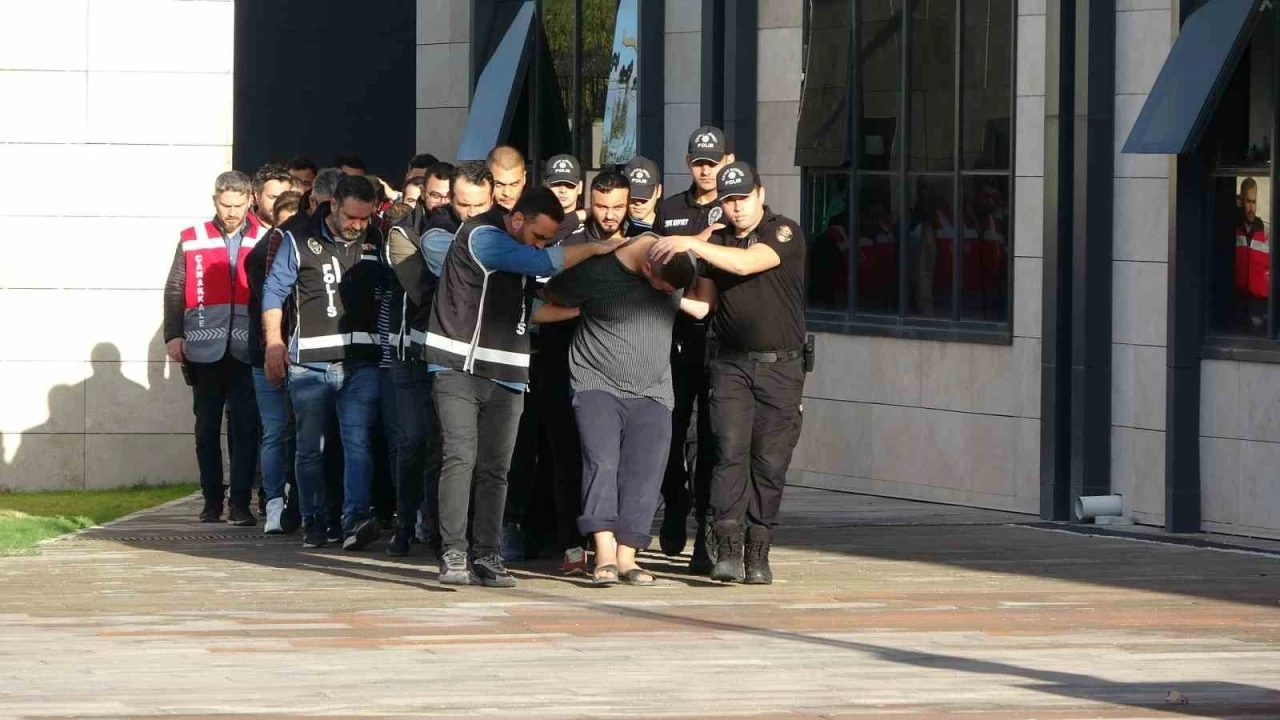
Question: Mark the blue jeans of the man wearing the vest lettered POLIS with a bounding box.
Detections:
[289,364,378,527]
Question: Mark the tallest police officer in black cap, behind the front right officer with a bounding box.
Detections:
[653,126,733,575]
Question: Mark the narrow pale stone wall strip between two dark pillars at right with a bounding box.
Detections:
[1111,0,1174,525]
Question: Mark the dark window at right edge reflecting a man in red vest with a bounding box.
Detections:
[1203,4,1277,346]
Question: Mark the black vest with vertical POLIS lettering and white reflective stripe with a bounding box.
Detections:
[292,211,384,363]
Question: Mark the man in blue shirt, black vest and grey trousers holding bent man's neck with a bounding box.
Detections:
[422,187,621,587]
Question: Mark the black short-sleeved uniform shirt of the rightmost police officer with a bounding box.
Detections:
[704,208,805,352]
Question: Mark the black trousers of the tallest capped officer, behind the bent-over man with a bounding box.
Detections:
[662,332,716,519]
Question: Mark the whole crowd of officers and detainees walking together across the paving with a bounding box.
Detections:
[165,127,812,587]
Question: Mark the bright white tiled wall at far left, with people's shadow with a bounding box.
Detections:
[0,0,233,489]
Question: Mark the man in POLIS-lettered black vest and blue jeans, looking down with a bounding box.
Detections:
[262,176,385,550]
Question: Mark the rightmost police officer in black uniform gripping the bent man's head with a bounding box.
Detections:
[653,163,808,584]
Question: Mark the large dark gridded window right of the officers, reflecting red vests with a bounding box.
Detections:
[796,0,1016,341]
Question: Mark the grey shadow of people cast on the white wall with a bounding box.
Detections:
[0,322,180,491]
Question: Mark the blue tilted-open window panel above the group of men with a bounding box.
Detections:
[457,0,534,160]
